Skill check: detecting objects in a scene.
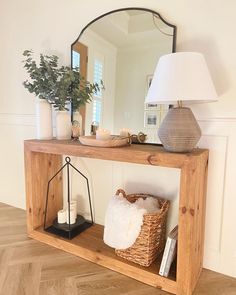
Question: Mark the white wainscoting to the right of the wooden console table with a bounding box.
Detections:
[199,118,236,277]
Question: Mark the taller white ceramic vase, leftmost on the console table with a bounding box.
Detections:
[36,99,53,140]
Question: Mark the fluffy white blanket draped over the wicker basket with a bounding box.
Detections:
[103,196,159,249]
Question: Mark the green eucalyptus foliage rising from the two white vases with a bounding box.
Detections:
[23,50,104,111]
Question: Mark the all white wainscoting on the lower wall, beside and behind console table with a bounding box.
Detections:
[0,113,236,277]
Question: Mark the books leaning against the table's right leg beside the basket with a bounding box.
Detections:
[159,225,178,277]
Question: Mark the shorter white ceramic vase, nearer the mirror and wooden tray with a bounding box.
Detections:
[56,111,71,140]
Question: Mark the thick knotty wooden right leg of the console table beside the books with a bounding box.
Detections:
[177,154,208,295]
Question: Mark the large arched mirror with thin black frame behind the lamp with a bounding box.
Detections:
[72,9,176,143]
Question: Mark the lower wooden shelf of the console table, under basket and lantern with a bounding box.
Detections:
[29,224,177,294]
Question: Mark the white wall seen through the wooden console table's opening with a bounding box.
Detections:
[72,158,180,229]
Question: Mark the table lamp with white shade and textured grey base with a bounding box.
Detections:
[145,52,217,153]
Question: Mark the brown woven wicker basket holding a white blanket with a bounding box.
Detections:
[115,189,170,266]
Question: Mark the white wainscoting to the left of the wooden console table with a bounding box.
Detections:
[0,113,35,208]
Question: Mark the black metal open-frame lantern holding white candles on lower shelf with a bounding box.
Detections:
[44,157,94,240]
